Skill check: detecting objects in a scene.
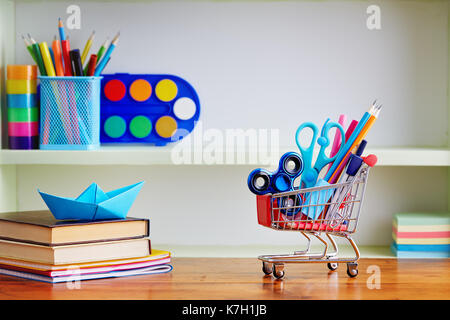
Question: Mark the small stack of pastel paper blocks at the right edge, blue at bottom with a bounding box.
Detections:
[391,212,450,258]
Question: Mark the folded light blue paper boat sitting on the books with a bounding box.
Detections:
[38,181,144,220]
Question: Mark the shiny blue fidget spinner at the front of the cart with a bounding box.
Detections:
[247,152,304,195]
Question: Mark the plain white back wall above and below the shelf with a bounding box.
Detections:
[11,1,448,252]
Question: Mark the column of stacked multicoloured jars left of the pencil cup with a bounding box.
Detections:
[6,65,39,149]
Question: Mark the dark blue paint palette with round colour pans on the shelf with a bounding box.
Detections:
[100,73,200,146]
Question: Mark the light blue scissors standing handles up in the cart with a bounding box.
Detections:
[295,119,345,188]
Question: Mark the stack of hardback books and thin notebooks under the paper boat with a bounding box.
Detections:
[0,211,172,283]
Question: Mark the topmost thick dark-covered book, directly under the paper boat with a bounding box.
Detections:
[0,210,150,246]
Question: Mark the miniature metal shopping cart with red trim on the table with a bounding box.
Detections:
[257,165,369,279]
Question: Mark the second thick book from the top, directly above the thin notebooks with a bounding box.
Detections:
[0,238,151,265]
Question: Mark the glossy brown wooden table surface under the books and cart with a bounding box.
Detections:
[0,258,450,300]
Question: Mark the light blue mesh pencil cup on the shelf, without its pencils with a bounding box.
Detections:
[38,76,102,150]
